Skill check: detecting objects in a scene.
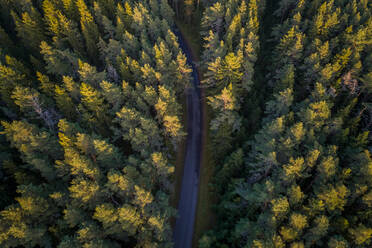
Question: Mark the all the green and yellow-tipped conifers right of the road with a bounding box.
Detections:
[200,0,372,248]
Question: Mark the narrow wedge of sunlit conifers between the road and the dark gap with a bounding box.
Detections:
[201,0,264,158]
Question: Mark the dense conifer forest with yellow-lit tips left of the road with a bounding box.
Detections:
[0,0,191,248]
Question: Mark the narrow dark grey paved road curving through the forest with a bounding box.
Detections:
[174,31,202,248]
